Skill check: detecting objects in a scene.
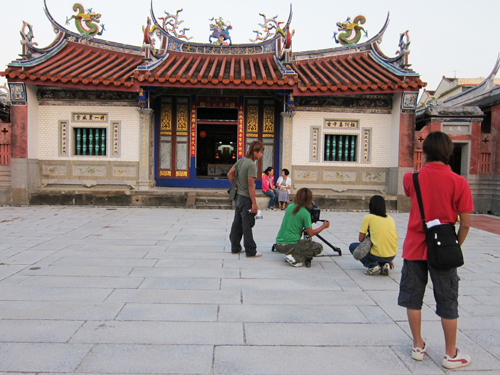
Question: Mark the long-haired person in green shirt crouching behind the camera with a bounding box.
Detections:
[276,188,330,267]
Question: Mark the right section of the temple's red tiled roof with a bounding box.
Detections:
[293,52,423,93]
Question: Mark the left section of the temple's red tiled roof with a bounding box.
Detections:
[5,42,142,88]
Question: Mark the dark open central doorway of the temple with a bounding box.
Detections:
[196,108,238,179]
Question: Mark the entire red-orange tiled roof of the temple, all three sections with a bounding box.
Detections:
[2,42,425,95]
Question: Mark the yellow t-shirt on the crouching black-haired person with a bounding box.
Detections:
[359,214,398,258]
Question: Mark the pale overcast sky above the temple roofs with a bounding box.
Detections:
[0,0,500,90]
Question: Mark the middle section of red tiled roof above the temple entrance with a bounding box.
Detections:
[134,52,297,88]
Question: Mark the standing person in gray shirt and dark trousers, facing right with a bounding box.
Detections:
[227,141,264,258]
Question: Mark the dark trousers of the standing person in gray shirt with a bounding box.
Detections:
[229,194,257,256]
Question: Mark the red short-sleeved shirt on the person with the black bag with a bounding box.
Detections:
[403,163,474,260]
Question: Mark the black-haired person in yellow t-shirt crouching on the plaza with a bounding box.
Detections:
[349,195,398,276]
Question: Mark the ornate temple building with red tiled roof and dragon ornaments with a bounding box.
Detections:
[0,4,425,209]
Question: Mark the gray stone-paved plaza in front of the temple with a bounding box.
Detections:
[0,206,500,375]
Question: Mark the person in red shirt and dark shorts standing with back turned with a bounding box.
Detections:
[398,132,474,368]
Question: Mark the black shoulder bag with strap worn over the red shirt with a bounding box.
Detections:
[413,171,464,268]
